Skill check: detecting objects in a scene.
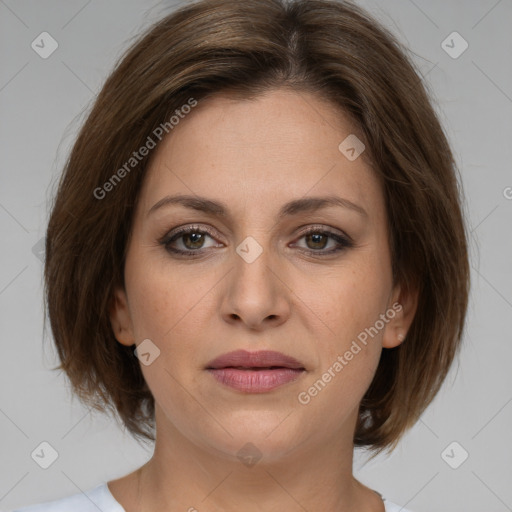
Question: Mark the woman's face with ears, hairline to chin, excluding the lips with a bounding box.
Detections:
[111,89,407,464]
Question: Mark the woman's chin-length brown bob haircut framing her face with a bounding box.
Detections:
[44,0,470,458]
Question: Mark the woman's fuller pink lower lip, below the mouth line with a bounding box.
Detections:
[208,368,305,393]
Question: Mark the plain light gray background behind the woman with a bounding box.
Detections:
[0,0,512,512]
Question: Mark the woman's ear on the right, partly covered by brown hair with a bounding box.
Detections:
[382,285,419,348]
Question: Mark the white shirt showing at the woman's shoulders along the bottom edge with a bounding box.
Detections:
[7,482,411,512]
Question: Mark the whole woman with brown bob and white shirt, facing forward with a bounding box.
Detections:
[11,0,469,512]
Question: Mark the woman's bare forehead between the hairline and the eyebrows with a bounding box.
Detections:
[134,89,383,222]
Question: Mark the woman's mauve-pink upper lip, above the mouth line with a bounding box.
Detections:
[206,350,305,370]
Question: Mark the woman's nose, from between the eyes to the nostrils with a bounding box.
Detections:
[222,241,292,331]
